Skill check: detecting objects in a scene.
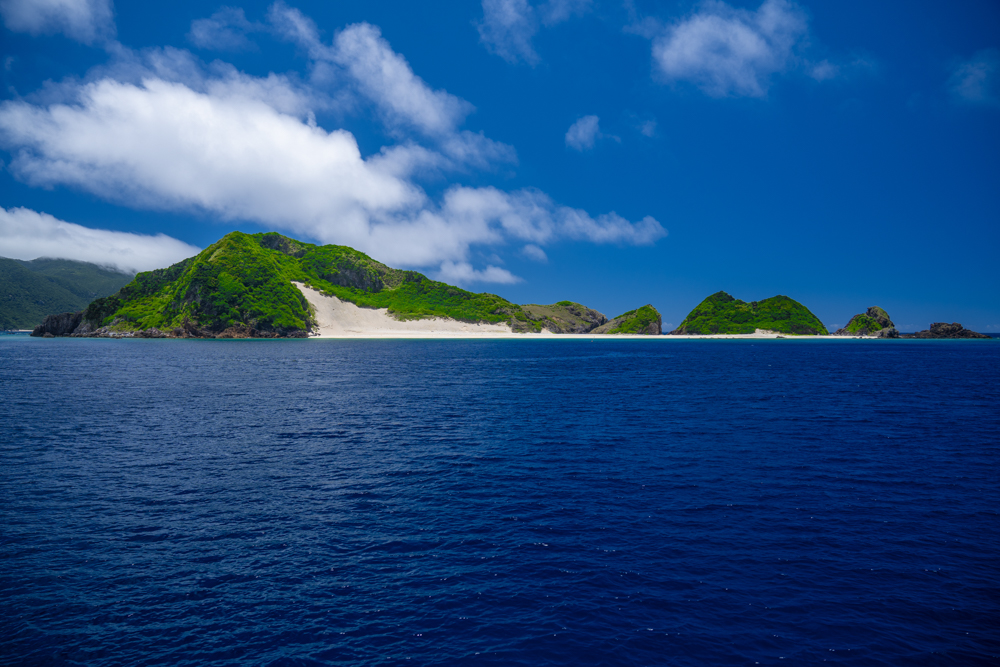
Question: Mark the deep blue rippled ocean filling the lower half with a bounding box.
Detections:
[0,336,1000,666]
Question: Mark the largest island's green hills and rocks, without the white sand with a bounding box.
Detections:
[27,232,661,337]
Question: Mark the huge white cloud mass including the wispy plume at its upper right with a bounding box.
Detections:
[0,5,666,282]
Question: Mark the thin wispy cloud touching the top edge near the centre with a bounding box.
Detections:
[477,0,593,65]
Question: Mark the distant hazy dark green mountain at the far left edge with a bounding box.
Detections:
[0,257,132,329]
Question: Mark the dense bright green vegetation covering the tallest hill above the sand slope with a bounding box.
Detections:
[85,232,535,332]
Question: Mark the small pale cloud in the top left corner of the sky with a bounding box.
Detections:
[0,0,115,44]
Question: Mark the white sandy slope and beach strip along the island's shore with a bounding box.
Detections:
[292,283,860,341]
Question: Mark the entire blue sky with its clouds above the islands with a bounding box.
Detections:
[0,0,1000,331]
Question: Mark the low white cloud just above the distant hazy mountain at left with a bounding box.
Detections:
[0,207,201,273]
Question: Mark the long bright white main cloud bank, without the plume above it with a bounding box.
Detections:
[0,79,665,275]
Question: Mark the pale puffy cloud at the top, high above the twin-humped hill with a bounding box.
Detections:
[653,0,808,97]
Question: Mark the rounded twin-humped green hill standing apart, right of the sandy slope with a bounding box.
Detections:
[674,292,827,335]
